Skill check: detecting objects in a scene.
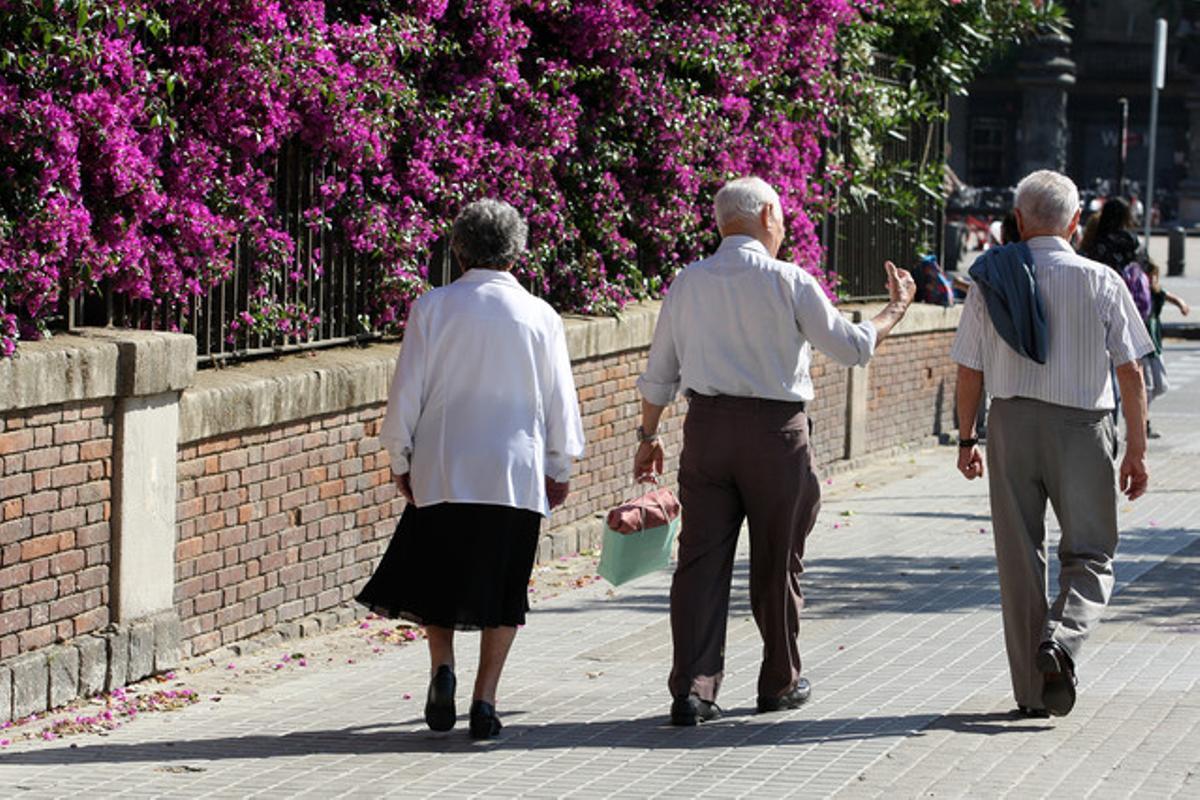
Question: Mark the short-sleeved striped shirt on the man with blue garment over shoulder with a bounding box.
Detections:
[950,236,1154,409]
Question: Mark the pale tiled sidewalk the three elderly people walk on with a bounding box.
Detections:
[0,424,1200,798]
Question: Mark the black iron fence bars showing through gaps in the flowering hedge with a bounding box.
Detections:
[58,71,944,366]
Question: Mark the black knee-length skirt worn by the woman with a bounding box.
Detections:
[356,503,541,631]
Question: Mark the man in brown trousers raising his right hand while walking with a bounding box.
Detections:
[634,178,914,726]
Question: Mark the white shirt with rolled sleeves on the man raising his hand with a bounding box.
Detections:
[637,236,876,405]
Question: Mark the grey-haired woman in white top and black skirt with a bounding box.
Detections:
[358,200,583,739]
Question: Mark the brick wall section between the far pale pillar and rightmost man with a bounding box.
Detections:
[866,331,958,450]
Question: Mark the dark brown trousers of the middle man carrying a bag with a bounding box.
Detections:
[667,395,821,700]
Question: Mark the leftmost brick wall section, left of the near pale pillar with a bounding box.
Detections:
[0,401,113,658]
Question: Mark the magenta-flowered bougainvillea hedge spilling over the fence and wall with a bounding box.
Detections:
[0,0,866,354]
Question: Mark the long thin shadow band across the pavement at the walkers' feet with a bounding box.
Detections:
[4,709,1051,766]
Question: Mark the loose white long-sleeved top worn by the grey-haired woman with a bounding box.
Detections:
[379,270,583,515]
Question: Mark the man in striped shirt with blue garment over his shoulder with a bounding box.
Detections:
[950,170,1153,717]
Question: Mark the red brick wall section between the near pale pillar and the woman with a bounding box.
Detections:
[175,405,403,655]
